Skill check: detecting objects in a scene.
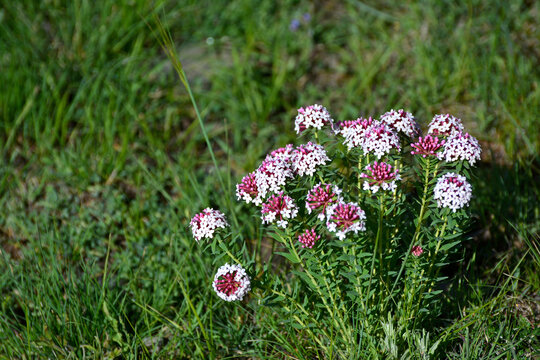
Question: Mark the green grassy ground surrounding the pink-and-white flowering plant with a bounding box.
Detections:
[0,0,540,359]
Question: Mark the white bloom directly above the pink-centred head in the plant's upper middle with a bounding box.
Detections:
[361,121,401,159]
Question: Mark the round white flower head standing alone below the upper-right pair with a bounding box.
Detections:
[433,173,472,212]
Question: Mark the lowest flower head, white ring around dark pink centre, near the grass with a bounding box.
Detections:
[212,264,251,301]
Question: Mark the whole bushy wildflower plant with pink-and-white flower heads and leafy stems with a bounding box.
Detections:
[192,105,481,354]
